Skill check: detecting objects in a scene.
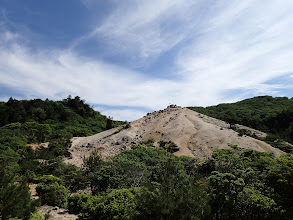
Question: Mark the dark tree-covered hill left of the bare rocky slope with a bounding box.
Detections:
[0,96,122,142]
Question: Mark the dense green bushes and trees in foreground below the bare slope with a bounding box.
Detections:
[68,145,293,219]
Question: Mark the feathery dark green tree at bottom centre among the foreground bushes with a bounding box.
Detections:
[135,156,210,219]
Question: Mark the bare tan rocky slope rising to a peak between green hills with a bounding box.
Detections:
[67,106,284,166]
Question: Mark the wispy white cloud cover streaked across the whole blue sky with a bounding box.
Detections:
[0,0,293,120]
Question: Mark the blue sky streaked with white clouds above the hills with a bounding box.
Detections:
[0,0,293,121]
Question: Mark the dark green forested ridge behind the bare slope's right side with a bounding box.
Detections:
[189,96,293,143]
